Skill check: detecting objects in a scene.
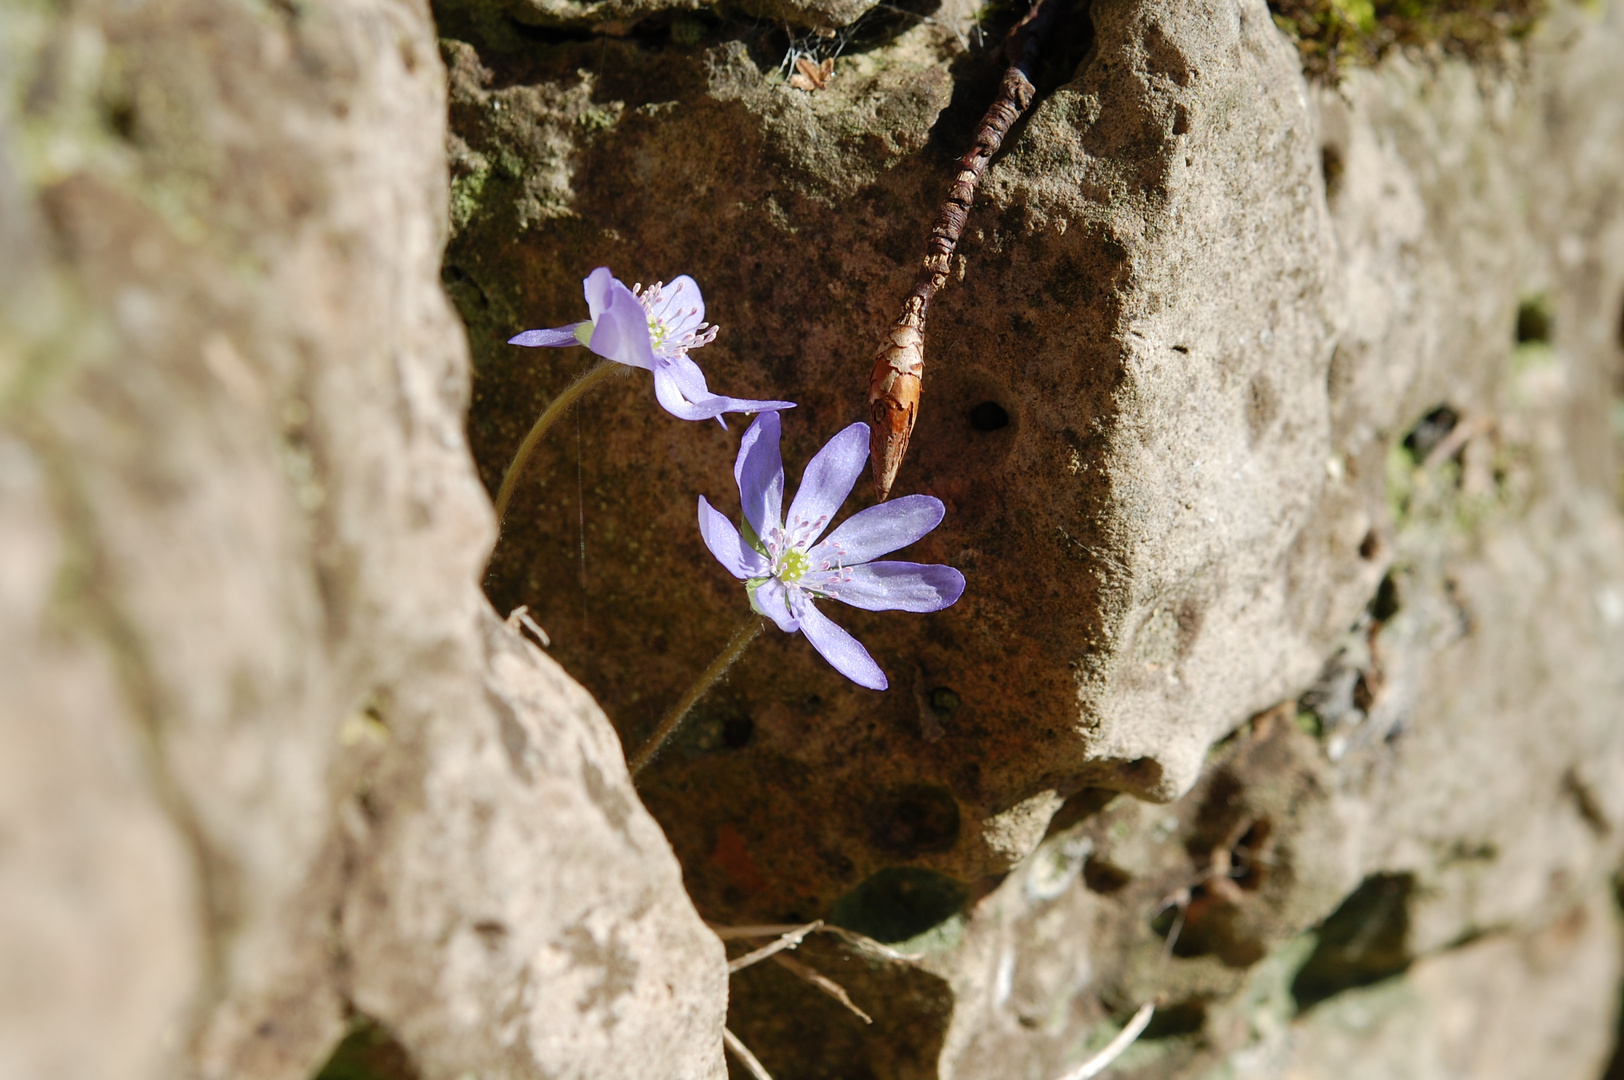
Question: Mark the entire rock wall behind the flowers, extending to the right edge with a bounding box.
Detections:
[445,0,1624,1080]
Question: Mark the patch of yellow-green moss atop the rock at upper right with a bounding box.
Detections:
[1268,0,1546,84]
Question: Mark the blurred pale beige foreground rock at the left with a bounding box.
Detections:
[0,0,726,1080]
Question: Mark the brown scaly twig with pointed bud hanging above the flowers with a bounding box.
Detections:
[869,0,1062,502]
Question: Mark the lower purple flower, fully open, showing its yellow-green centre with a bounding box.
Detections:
[700,413,965,690]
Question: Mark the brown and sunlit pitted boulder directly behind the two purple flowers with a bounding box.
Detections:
[448,6,1357,914]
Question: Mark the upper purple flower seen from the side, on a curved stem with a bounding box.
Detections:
[508,266,796,427]
